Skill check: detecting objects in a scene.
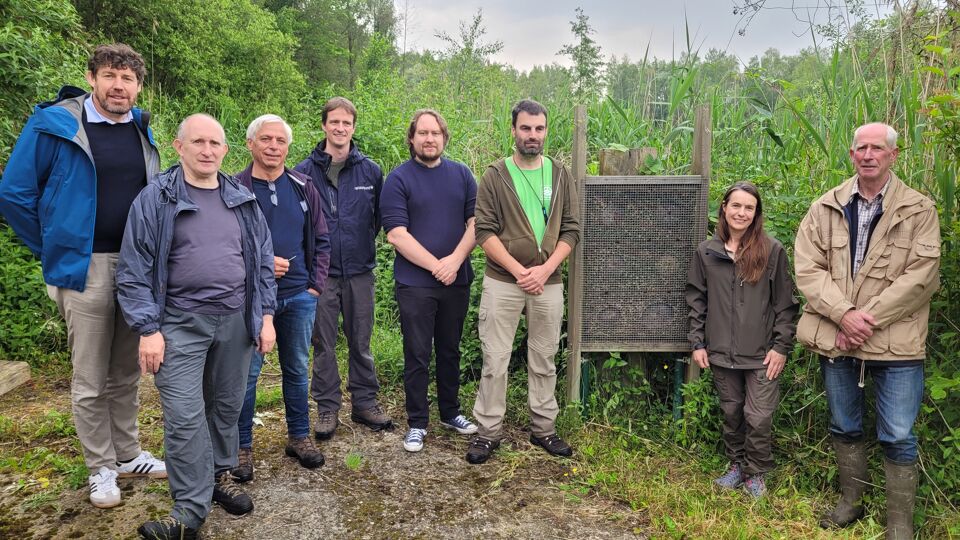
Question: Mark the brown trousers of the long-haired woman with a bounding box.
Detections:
[710,365,780,476]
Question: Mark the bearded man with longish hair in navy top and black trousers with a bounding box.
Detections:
[380,109,477,452]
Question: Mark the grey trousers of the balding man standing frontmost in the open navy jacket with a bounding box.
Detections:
[154,307,253,529]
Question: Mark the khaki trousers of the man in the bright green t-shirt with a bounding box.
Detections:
[473,278,563,440]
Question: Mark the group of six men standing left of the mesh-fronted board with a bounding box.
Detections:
[0,44,579,539]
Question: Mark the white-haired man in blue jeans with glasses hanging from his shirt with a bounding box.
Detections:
[233,114,330,476]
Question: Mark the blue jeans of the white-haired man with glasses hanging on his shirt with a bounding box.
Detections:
[239,291,317,448]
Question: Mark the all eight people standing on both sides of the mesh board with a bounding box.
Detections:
[0,44,940,539]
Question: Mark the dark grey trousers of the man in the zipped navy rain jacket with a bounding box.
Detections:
[310,272,380,411]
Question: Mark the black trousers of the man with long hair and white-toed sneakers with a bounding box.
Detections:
[396,283,470,429]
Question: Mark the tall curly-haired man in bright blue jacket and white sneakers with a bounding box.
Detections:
[0,43,167,508]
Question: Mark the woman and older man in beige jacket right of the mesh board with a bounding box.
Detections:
[686,123,940,539]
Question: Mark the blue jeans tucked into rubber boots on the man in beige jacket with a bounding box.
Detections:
[820,356,923,465]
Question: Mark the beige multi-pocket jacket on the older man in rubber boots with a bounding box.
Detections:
[794,172,940,361]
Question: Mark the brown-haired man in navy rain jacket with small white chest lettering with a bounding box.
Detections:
[294,97,393,440]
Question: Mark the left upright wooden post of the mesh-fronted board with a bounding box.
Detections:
[567,105,587,403]
